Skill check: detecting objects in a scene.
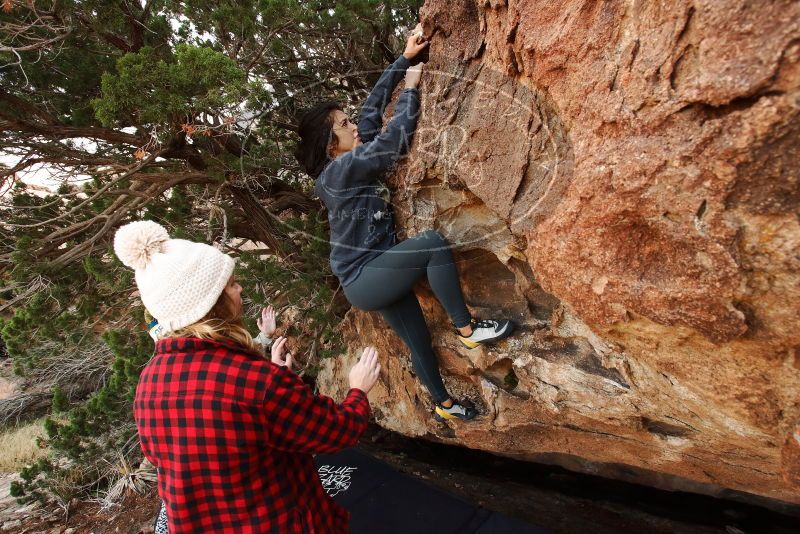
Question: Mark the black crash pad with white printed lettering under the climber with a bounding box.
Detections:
[315,449,550,534]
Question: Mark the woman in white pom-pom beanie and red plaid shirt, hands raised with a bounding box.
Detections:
[114,221,380,533]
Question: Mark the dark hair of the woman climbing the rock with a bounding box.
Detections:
[294,100,342,178]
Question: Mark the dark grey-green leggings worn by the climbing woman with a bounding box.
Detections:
[344,230,472,403]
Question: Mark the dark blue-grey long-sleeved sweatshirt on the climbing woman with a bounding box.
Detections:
[314,56,419,286]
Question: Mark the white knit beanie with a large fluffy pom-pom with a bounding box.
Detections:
[114,221,234,331]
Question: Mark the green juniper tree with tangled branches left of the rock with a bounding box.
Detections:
[0,0,421,502]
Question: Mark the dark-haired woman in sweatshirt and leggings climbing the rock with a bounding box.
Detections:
[296,26,513,419]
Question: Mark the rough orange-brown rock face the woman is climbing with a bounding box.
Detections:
[320,0,800,503]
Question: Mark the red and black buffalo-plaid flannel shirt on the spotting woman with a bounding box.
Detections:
[134,338,369,534]
